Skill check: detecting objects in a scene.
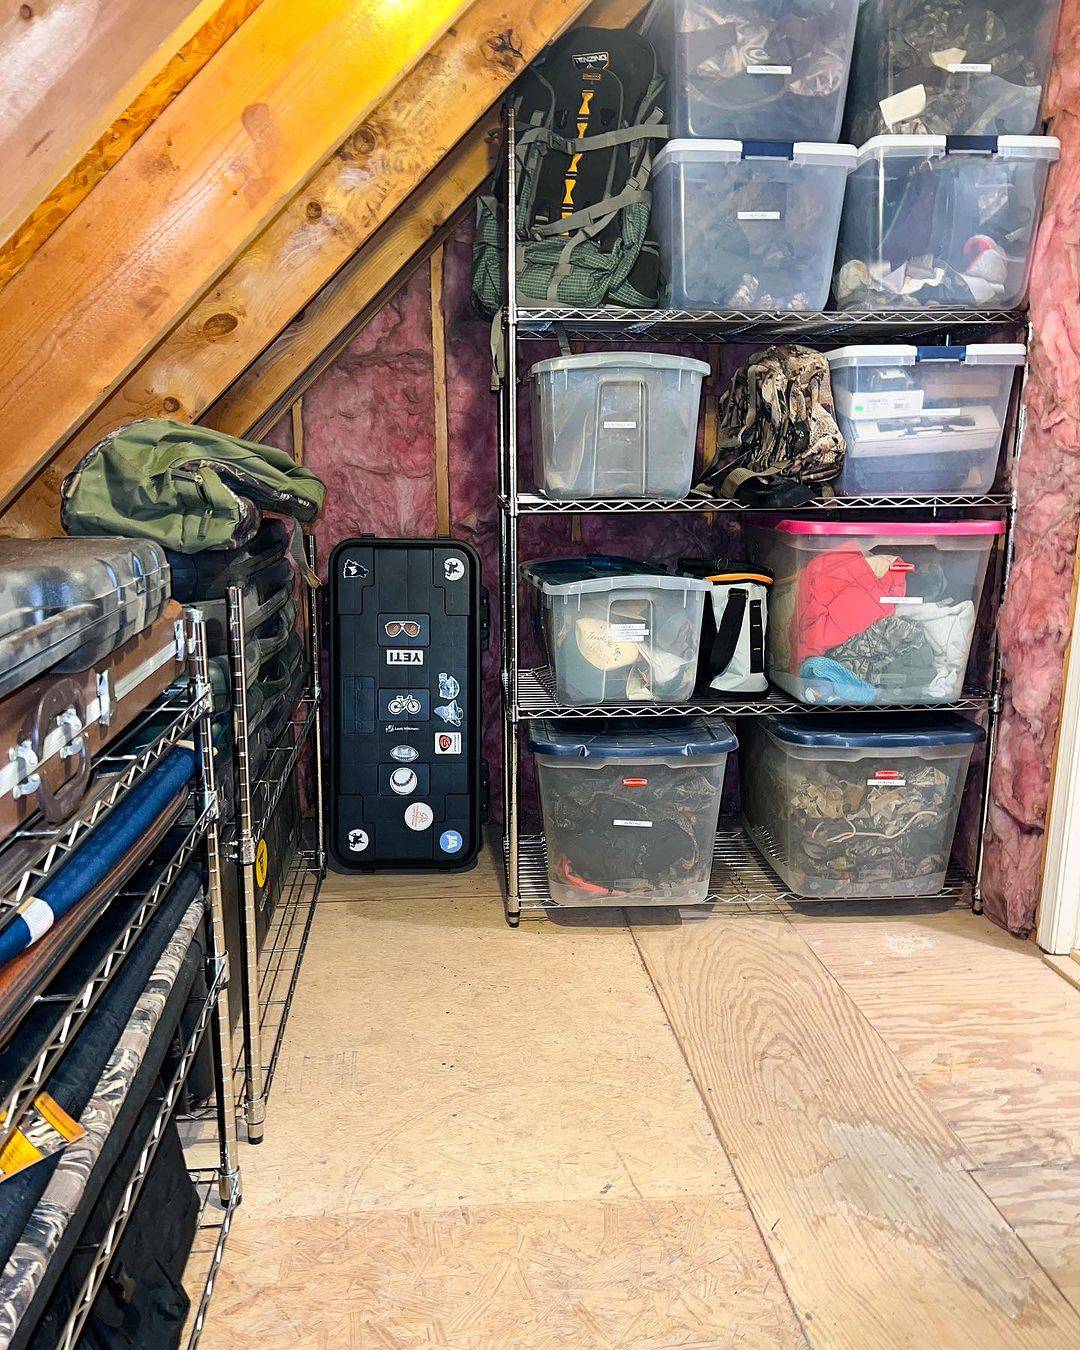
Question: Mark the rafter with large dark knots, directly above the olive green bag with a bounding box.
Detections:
[0,0,644,533]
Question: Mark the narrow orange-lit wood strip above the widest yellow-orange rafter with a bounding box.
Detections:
[0,0,262,286]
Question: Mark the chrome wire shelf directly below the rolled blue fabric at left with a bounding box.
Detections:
[0,802,217,1155]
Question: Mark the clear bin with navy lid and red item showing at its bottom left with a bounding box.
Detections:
[528,717,738,905]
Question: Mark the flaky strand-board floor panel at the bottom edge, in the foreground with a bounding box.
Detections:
[201,1195,805,1350]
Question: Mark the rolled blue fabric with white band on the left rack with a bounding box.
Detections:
[0,747,194,967]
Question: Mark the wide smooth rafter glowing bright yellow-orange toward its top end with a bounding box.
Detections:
[0,0,472,506]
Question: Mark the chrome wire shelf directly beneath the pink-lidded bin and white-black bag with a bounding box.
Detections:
[517,666,990,721]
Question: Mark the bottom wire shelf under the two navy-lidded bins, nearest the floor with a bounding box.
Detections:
[517,818,971,914]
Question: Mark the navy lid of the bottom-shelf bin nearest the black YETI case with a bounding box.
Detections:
[529,717,738,760]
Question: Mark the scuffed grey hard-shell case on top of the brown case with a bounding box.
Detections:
[0,539,170,697]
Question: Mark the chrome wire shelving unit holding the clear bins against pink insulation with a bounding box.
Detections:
[497,107,1030,926]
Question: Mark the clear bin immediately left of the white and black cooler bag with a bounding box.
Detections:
[522,554,710,703]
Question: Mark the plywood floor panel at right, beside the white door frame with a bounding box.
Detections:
[791,909,1080,1166]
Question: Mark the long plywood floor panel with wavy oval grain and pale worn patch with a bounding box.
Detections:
[635,914,1080,1350]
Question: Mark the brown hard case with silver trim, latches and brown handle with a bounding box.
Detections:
[0,601,185,841]
